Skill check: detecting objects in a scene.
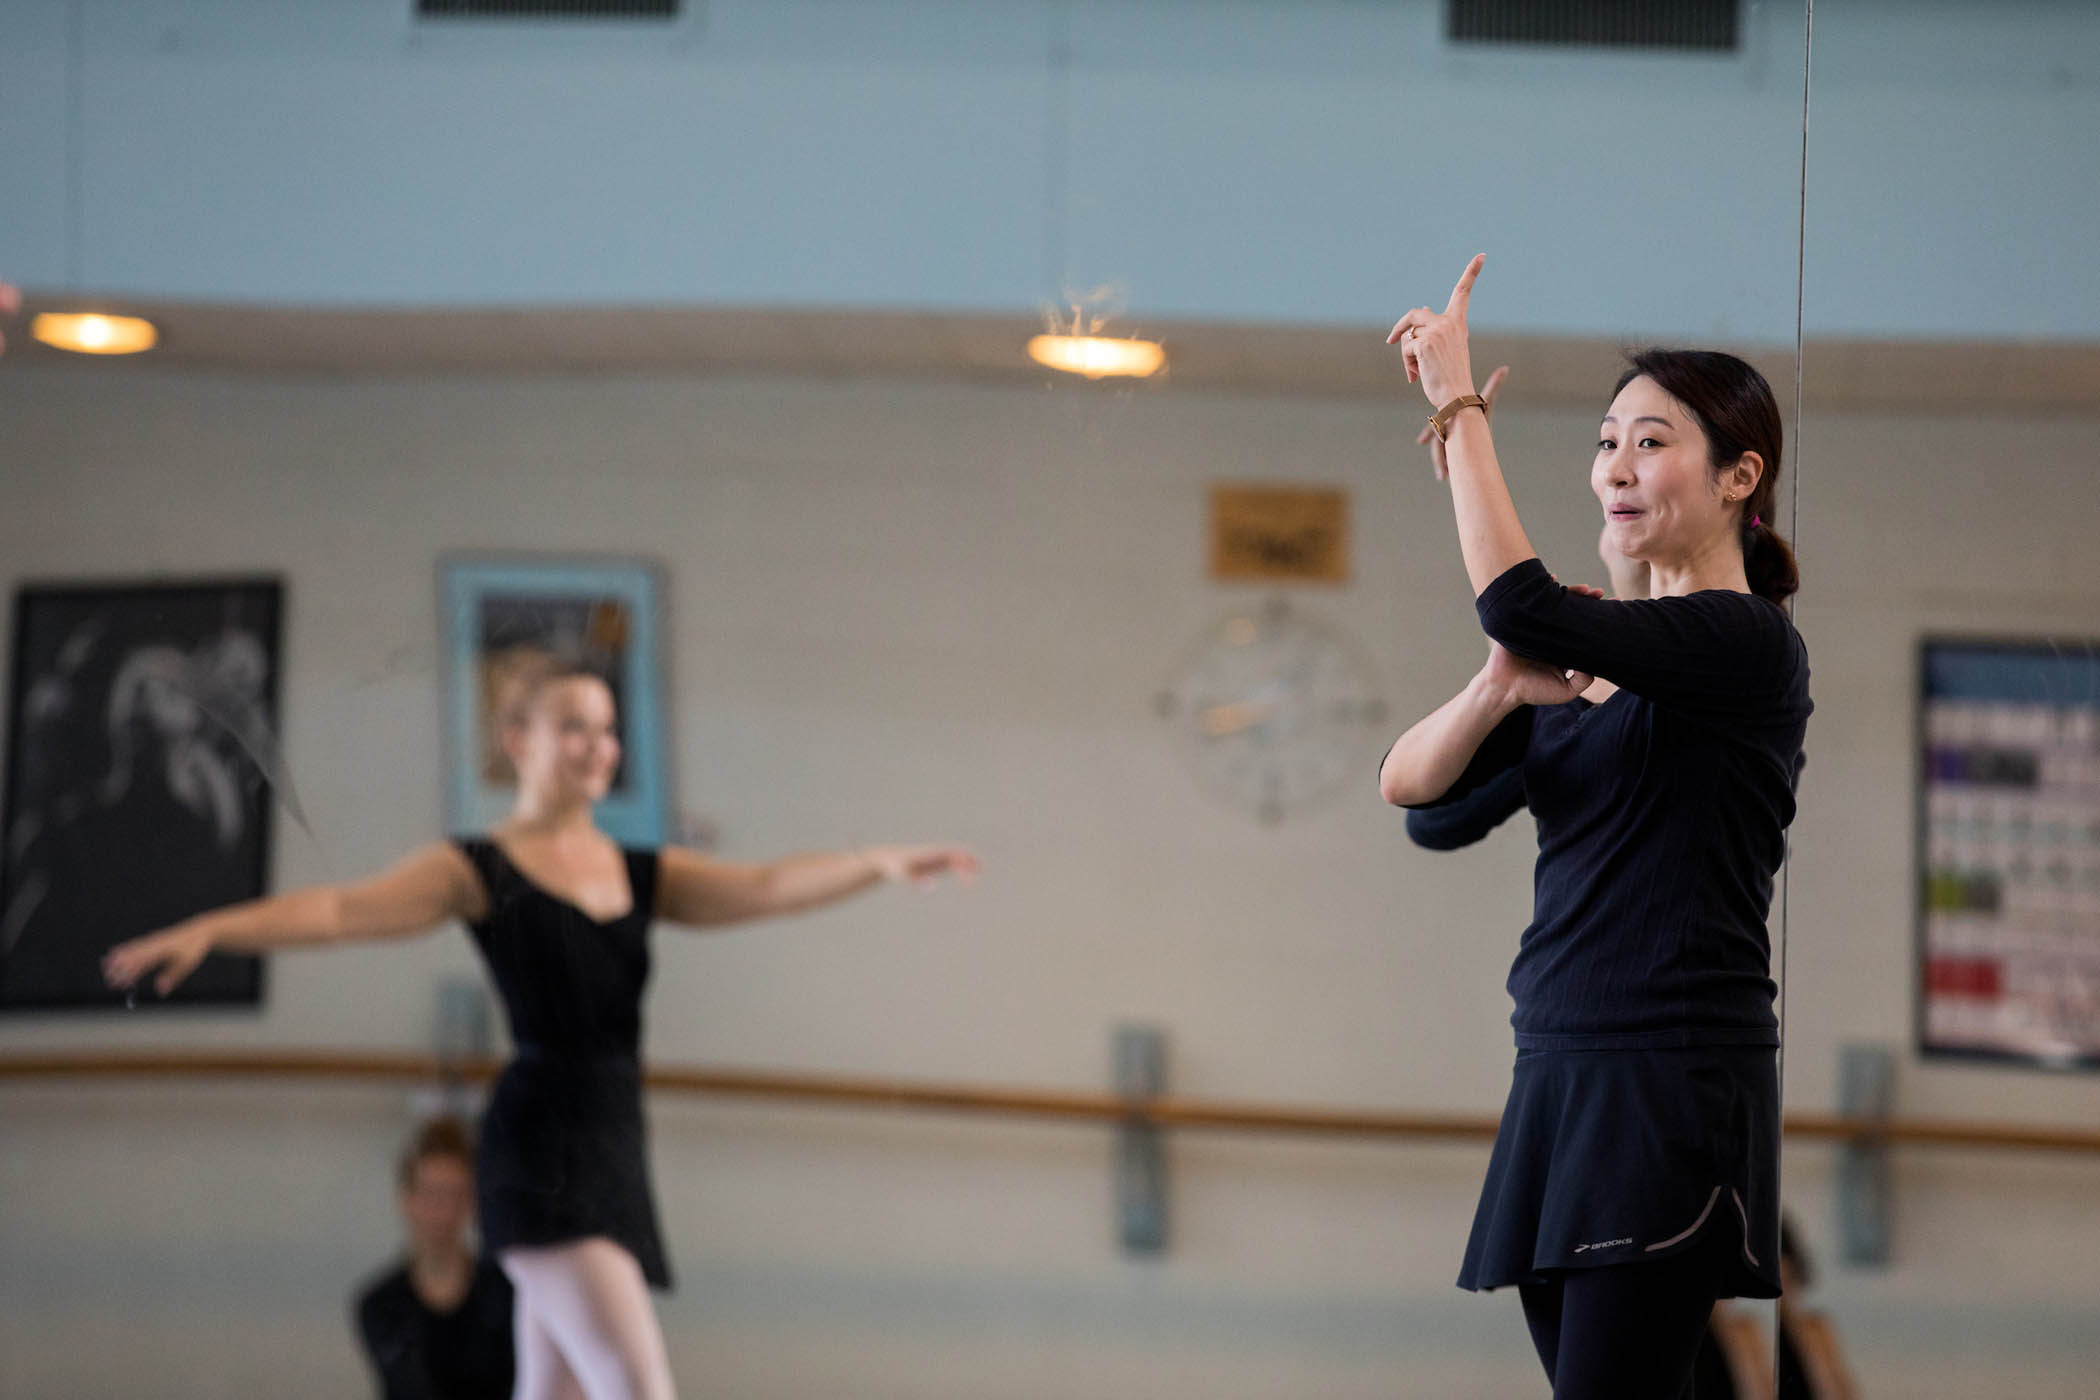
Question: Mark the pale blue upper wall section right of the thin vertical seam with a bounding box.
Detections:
[1806,0,2100,340]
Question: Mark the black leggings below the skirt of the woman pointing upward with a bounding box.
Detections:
[1518,1230,1735,1400]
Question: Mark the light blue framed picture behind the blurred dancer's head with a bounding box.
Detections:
[439,556,670,846]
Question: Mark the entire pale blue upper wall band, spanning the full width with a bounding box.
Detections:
[0,0,2100,340]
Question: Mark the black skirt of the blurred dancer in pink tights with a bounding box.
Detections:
[475,1052,670,1289]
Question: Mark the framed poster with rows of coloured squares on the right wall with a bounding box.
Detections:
[1917,638,2100,1068]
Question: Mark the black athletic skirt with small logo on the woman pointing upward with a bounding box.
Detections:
[1457,1045,1779,1297]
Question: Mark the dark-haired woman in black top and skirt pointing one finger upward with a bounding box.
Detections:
[1380,258,1810,1400]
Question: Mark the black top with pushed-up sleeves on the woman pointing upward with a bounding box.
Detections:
[1422,558,1814,1049]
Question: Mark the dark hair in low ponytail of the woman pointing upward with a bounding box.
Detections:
[1613,348,1802,604]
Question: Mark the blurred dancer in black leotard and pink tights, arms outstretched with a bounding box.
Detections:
[105,661,977,1400]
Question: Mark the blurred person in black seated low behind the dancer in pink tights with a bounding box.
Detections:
[357,1119,517,1400]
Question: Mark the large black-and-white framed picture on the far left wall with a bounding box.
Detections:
[0,579,284,1010]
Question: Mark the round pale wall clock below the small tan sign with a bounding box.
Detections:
[1157,598,1386,825]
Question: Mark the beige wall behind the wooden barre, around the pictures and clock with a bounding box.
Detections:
[0,365,2100,1398]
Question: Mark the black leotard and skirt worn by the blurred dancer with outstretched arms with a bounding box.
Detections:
[456,840,672,1289]
